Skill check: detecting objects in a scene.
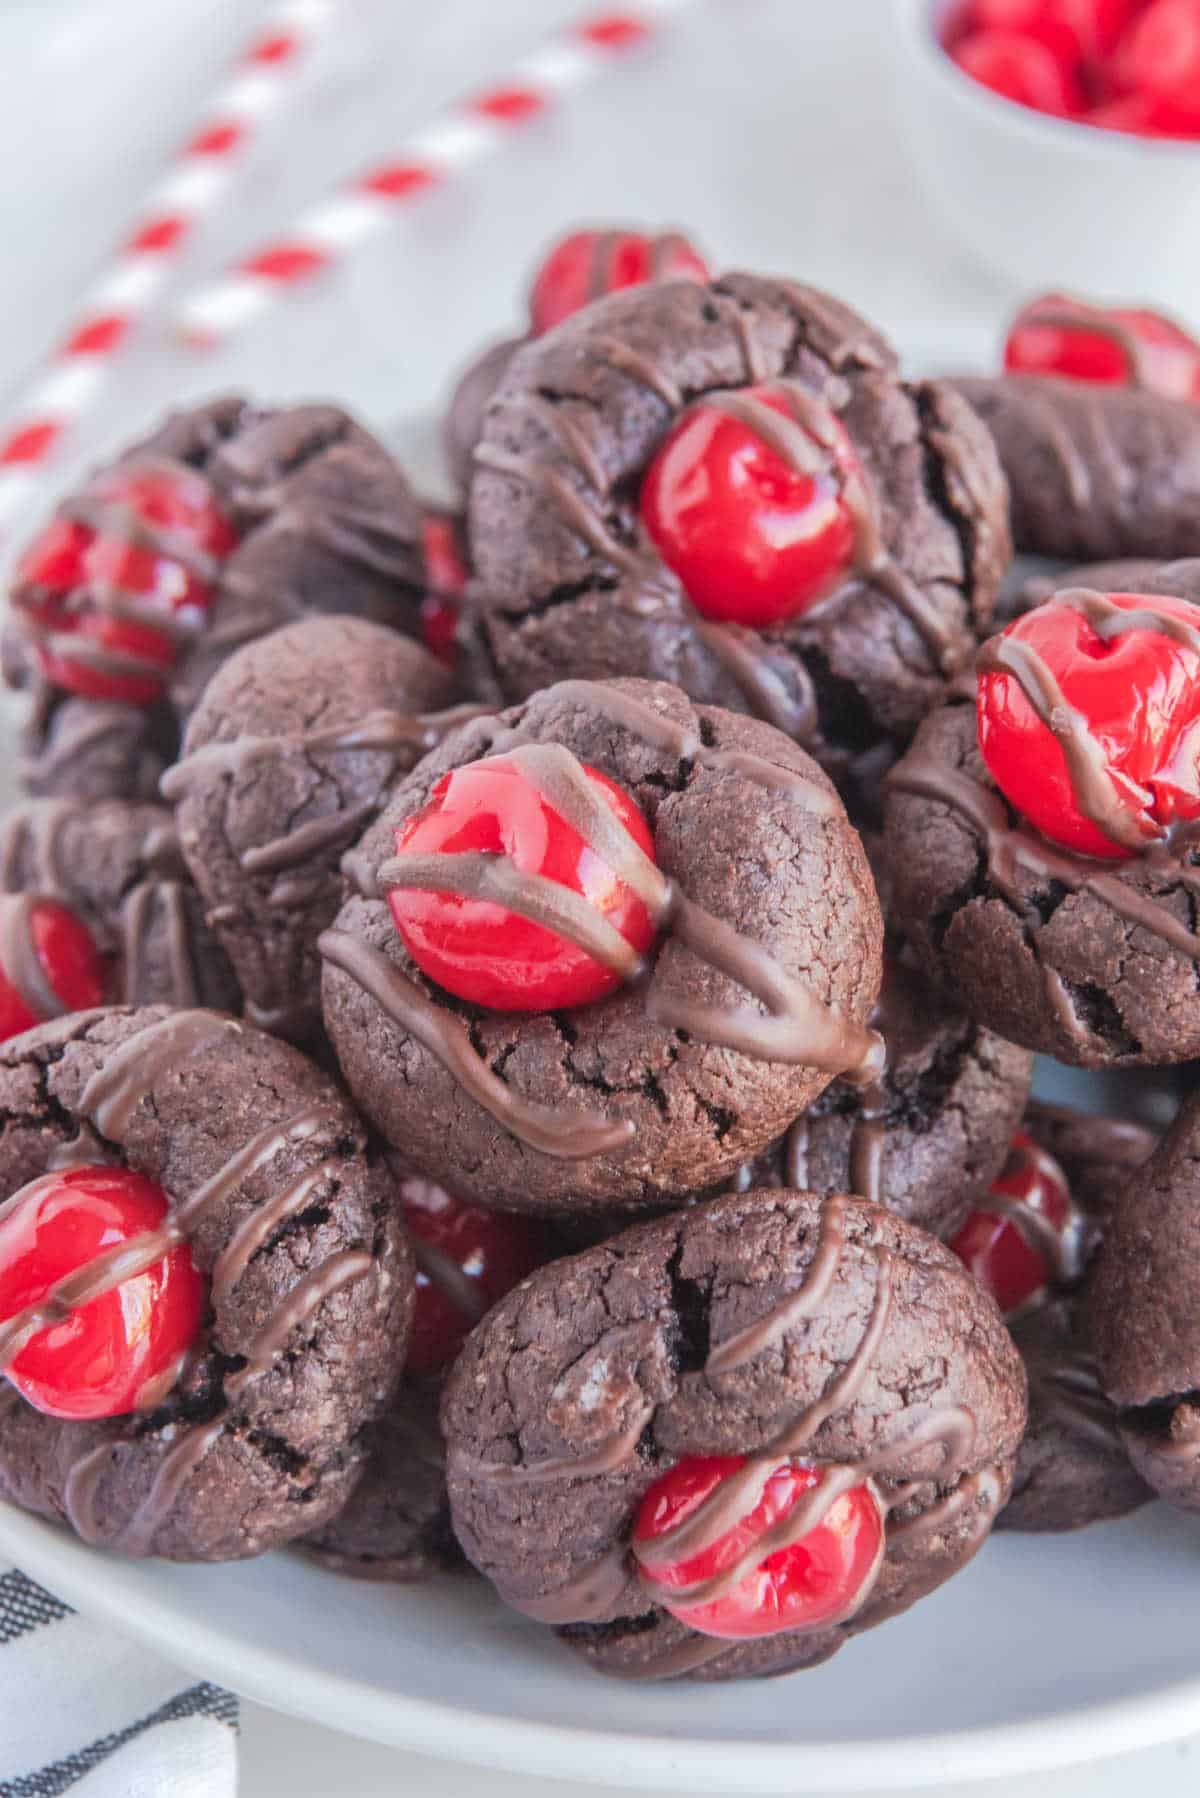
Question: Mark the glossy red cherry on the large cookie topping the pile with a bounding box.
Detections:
[640,385,860,629]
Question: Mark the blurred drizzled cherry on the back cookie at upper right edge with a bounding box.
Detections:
[1004,293,1200,399]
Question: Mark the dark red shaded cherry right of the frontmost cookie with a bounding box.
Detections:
[948,1131,1078,1316]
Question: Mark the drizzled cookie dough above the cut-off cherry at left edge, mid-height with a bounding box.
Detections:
[0,798,241,1010]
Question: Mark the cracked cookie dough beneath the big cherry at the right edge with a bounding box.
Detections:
[885,703,1200,1068]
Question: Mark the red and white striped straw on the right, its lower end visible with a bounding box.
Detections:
[176,0,691,347]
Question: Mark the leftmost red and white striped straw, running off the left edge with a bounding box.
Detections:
[0,0,335,532]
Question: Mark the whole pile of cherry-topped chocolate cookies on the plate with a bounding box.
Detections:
[0,230,1200,1679]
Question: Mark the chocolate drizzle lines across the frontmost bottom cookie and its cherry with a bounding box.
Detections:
[474,1197,1004,1679]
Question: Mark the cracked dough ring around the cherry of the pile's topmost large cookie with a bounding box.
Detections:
[470,275,1009,809]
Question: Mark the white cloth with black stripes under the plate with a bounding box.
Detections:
[0,1568,237,1798]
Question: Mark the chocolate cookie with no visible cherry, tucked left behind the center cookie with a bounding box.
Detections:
[162,617,470,1041]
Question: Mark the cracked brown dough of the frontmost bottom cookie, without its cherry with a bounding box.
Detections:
[443,1192,1025,1679]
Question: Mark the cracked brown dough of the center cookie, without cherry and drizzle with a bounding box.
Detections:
[324,681,882,1210]
